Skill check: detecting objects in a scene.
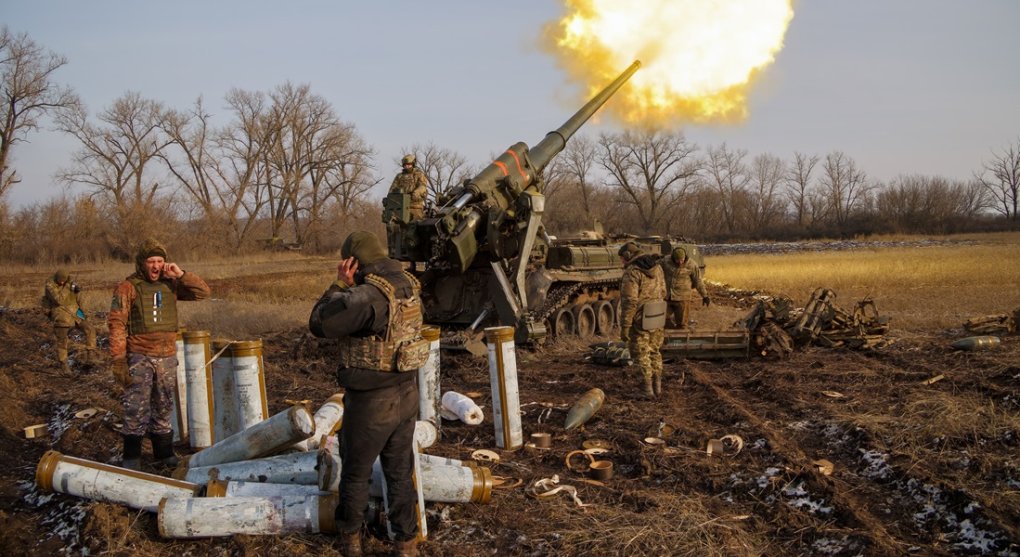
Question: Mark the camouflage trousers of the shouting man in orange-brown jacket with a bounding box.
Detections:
[121,354,177,436]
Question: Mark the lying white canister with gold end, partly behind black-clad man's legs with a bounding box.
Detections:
[318,454,493,503]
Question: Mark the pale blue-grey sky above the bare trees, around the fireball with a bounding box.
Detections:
[0,0,1020,207]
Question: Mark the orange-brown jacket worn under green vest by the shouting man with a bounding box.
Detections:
[106,271,209,359]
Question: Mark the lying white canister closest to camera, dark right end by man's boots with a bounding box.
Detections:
[158,494,337,538]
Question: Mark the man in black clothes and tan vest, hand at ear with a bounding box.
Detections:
[308,232,428,557]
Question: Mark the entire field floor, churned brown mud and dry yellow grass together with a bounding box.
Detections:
[0,235,1020,557]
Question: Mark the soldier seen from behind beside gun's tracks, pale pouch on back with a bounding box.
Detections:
[619,242,666,398]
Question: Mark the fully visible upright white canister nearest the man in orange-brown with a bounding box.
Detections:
[183,331,213,449]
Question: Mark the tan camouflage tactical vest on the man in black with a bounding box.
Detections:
[340,271,429,372]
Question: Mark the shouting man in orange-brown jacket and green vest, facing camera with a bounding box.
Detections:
[107,239,209,470]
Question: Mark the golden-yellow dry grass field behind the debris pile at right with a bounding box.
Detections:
[707,234,1020,331]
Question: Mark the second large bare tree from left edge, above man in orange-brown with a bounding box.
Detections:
[57,92,171,249]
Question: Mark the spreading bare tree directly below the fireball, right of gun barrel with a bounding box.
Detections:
[598,131,699,234]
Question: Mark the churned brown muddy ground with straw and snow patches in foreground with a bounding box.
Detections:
[0,281,1020,556]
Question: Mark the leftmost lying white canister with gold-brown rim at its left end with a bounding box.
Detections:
[36,451,202,512]
